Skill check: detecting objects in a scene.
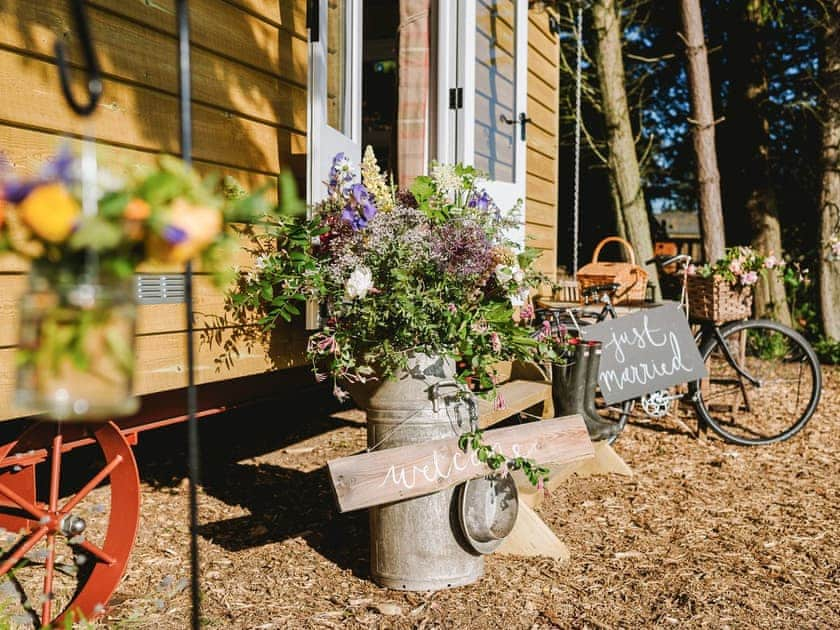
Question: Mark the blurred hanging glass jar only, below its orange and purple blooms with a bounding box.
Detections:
[15,266,139,421]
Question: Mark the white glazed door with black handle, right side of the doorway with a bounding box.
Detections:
[437,0,528,244]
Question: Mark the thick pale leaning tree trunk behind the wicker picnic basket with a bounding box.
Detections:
[592,0,659,298]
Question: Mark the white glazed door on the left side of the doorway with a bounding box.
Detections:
[306,0,362,204]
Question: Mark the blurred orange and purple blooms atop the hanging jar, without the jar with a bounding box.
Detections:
[0,150,268,283]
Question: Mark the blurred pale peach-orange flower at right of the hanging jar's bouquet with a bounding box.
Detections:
[149,199,223,264]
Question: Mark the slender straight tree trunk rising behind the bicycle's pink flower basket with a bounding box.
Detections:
[680,0,726,262]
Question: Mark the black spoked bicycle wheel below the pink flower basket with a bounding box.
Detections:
[695,319,822,445]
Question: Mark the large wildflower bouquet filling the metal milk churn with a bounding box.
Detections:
[232,148,547,397]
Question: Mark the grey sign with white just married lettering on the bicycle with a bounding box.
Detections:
[583,302,707,404]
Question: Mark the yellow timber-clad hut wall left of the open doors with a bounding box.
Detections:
[0,0,308,419]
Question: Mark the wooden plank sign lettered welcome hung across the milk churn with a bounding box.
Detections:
[327,415,595,512]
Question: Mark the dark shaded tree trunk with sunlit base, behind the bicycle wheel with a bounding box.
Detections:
[727,0,791,325]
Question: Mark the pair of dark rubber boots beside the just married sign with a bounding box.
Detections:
[551,341,618,442]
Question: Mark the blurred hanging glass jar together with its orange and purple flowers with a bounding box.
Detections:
[0,145,268,419]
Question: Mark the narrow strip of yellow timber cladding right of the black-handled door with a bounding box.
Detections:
[525,13,559,279]
